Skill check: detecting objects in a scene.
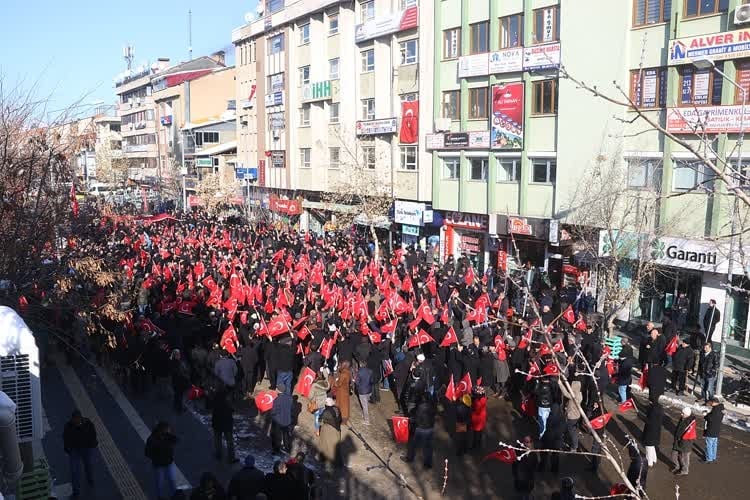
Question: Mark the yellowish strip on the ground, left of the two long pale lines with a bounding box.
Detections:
[58,363,147,500]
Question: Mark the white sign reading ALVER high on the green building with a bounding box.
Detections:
[667,28,750,66]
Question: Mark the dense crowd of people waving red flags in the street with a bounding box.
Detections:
[47,212,723,499]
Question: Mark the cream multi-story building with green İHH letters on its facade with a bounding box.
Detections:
[232,0,433,229]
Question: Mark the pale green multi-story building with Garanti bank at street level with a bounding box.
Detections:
[428,0,750,347]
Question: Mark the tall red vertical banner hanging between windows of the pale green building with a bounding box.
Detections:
[490,82,524,149]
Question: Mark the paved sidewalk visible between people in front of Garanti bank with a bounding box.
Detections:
[615,328,750,431]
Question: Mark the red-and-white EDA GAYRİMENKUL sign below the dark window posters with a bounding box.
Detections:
[667,105,750,134]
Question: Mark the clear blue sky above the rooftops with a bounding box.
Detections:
[0,0,257,111]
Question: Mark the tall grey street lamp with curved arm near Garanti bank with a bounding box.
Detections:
[693,57,747,396]
